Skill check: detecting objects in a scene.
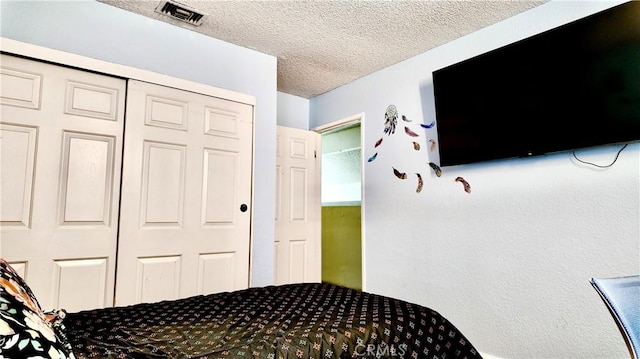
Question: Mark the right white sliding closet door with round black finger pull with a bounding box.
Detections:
[116,81,253,305]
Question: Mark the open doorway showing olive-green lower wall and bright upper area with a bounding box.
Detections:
[314,115,363,290]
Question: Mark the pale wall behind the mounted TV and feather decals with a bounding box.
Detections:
[310,1,640,358]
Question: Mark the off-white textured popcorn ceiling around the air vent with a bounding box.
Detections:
[99,0,548,98]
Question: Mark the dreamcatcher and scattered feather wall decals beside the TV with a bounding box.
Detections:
[367,105,471,193]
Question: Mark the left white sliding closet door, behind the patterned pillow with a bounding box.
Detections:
[0,55,126,311]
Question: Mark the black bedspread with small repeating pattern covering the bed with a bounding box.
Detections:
[65,283,480,359]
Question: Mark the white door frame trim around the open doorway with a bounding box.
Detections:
[311,112,367,291]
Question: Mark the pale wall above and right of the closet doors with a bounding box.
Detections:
[0,1,277,286]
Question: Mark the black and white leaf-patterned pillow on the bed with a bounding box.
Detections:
[0,258,74,359]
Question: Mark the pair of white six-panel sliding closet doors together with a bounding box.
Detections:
[0,54,253,311]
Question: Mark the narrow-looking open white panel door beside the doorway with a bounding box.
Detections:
[275,126,322,284]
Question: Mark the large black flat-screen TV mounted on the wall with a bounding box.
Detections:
[433,1,640,166]
